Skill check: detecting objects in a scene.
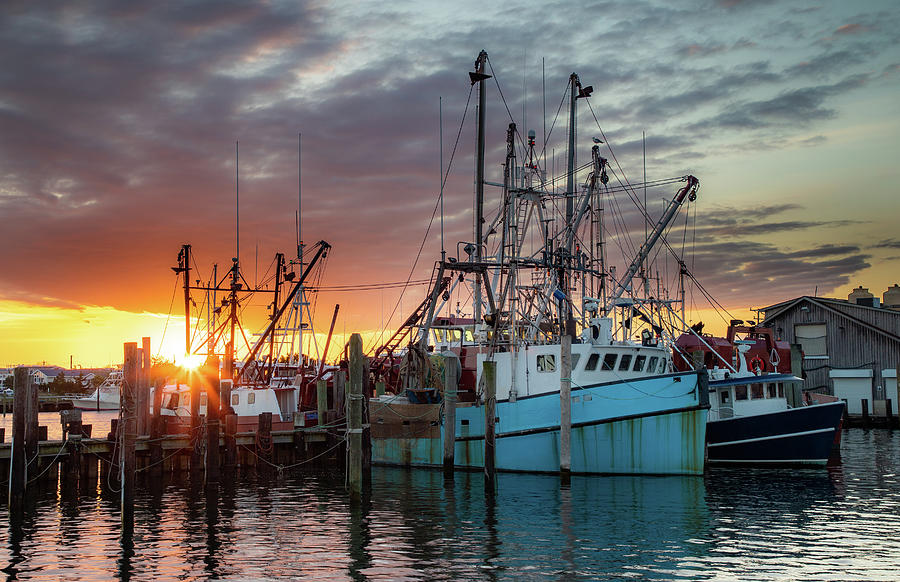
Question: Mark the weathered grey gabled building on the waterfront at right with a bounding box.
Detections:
[760,285,900,406]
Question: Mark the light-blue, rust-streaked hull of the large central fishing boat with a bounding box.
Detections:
[370,373,707,475]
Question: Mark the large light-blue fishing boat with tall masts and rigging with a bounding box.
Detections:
[369,51,708,475]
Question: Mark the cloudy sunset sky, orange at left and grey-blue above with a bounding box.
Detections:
[0,0,900,367]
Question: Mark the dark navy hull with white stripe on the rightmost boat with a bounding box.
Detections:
[706,402,844,465]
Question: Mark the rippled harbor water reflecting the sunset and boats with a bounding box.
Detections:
[0,429,900,582]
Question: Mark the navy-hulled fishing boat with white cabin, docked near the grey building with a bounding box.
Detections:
[675,321,844,465]
